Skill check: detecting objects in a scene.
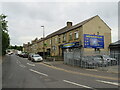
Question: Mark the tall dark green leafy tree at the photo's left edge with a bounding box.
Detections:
[0,14,10,55]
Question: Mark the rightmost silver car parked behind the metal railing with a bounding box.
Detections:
[96,55,117,65]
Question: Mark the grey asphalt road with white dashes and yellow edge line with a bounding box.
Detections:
[2,55,119,90]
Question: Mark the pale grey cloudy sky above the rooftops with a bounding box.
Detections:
[0,0,118,45]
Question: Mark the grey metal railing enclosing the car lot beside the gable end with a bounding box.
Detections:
[64,52,120,68]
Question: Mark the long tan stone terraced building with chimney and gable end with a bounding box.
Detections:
[23,15,111,56]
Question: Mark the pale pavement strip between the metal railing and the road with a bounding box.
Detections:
[43,61,120,73]
